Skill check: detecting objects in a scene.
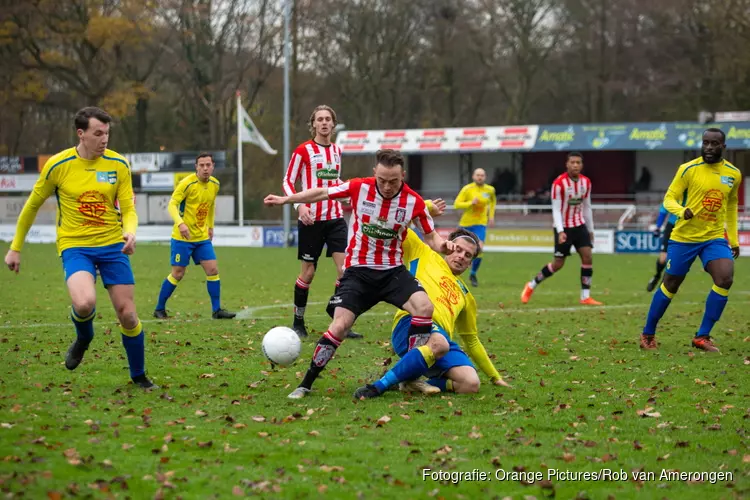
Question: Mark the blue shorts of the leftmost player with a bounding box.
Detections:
[60,243,135,286]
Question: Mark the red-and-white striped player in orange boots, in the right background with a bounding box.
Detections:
[521,152,602,306]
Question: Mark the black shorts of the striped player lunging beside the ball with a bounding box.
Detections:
[327,266,424,316]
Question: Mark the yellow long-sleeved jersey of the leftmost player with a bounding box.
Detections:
[10,148,138,254]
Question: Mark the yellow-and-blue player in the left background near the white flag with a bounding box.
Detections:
[154,153,236,319]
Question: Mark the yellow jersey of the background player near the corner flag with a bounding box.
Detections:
[167,174,220,241]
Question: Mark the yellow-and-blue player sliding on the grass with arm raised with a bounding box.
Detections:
[354,228,510,399]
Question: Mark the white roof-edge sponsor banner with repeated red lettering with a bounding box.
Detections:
[336,125,538,154]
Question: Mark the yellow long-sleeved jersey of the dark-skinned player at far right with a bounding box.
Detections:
[664,158,742,247]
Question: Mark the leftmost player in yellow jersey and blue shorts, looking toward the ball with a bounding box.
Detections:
[5,107,156,389]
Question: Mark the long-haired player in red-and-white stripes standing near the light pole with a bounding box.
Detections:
[283,104,361,338]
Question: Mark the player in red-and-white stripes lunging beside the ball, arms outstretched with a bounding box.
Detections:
[264,149,454,399]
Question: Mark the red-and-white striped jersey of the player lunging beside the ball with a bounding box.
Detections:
[328,177,435,270]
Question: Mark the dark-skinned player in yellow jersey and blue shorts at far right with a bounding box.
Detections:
[641,128,742,352]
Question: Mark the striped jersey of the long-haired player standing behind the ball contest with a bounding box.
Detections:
[283,140,344,221]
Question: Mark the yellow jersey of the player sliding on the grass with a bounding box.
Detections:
[393,229,501,381]
